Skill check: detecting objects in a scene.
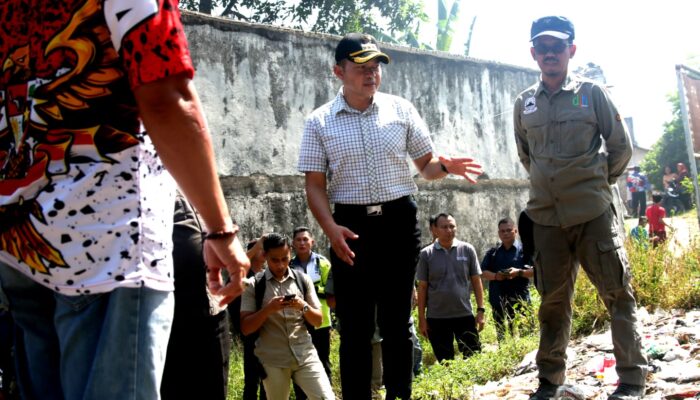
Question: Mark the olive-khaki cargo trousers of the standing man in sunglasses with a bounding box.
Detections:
[533,206,648,385]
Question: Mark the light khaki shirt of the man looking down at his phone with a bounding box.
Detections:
[241,269,321,368]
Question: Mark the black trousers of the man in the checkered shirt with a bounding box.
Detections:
[331,196,420,400]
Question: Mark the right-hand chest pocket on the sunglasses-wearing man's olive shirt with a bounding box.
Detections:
[551,108,601,158]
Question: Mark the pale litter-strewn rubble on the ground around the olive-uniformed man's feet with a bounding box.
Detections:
[473,308,700,400]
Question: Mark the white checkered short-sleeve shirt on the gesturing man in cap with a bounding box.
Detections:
[298,88,433,204]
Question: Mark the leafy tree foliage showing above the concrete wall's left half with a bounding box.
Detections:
[180,0,427,40]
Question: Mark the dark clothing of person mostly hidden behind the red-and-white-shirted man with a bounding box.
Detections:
[160,196,231,400]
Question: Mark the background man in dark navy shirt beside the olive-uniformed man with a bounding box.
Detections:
[481,217,533,342]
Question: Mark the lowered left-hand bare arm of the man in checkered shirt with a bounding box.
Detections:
[305,172,358,265]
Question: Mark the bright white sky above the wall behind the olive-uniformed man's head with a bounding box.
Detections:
[421,0,700,148]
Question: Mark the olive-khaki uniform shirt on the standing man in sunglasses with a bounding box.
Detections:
[513,77,632,228]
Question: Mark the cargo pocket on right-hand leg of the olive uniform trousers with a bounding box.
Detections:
[598,236,630,292]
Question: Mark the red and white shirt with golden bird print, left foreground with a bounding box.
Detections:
[0,0,194,295]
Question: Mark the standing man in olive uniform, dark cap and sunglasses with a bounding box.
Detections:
[513,17,647,400]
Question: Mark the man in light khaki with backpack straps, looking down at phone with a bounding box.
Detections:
[241,233,335,400]
